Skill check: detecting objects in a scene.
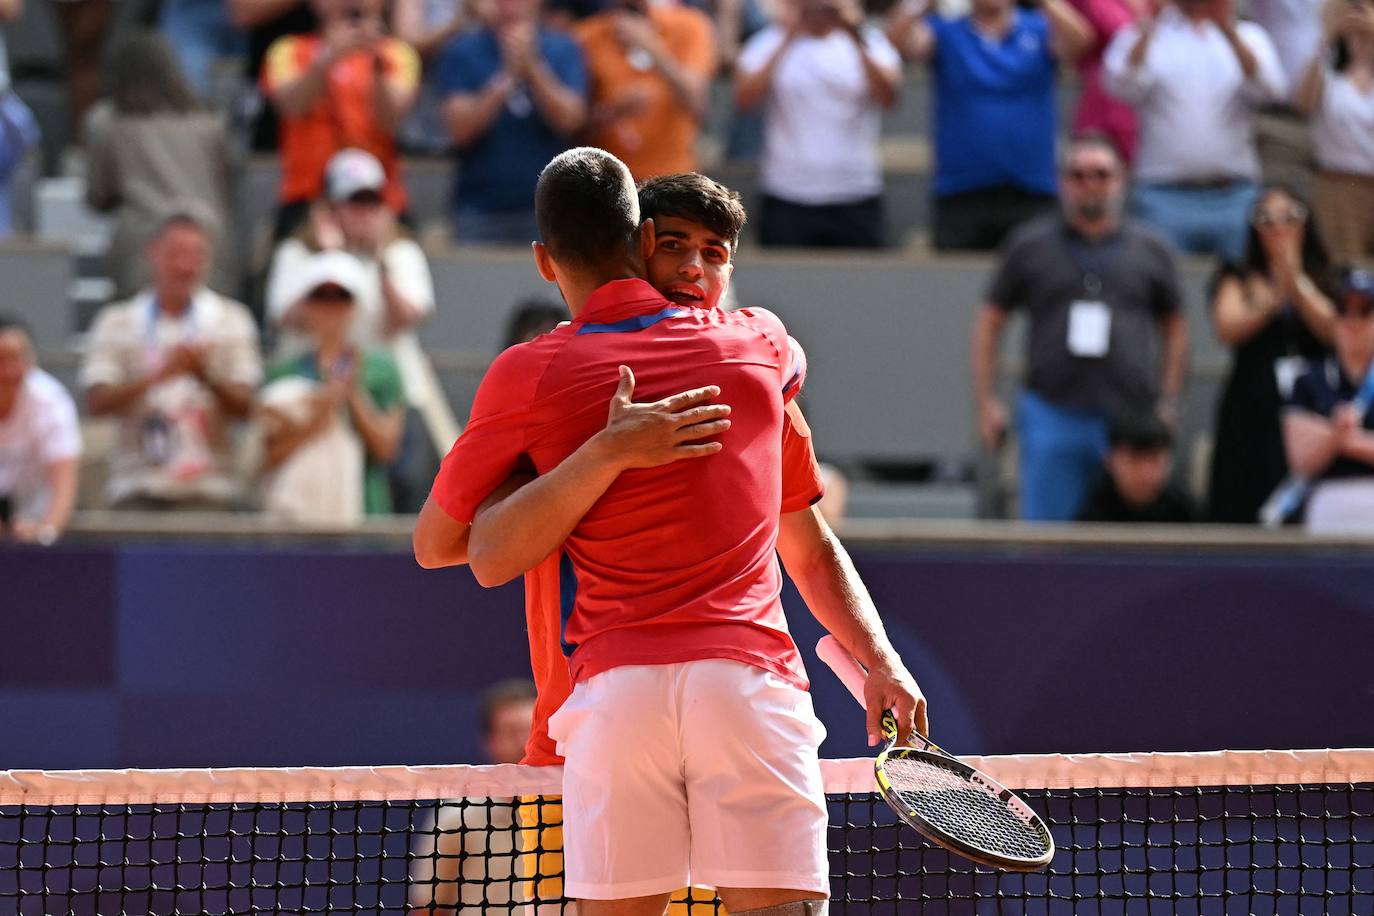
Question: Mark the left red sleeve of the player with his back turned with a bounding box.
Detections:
[431,346,540,523]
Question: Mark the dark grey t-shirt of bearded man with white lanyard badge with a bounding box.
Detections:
[988,216,1183,413]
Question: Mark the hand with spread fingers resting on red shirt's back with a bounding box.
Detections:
[598,365,730,470]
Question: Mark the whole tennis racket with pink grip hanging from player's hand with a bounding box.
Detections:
[816,636,1054,872]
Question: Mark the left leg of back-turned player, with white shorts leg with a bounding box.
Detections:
[548,665,690,916]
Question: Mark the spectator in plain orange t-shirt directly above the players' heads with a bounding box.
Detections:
[574,0,716,181]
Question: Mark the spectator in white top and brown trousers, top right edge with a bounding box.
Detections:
[1293,0,1374,270]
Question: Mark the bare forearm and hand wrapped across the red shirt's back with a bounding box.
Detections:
[467,365,730,588]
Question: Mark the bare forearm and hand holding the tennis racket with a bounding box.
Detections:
[778,505,930,746]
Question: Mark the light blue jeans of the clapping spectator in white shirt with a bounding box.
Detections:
[1131,181,1260,262]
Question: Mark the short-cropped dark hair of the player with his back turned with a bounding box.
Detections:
[534,147,640,269]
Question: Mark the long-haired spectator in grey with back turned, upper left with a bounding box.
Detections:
[85,32,238,298]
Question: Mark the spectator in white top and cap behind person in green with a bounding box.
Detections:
[258,150,458,512]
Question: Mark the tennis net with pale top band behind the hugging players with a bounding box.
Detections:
[0,750,1374,916]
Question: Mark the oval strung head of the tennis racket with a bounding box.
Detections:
[882,758,1048,860]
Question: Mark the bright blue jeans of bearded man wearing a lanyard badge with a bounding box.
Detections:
[1017,391,1109,522]
